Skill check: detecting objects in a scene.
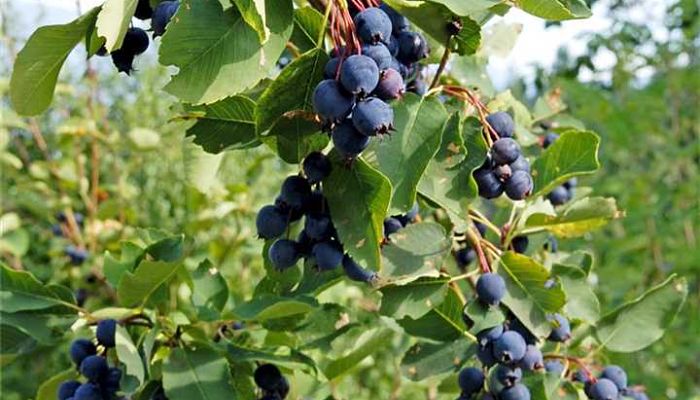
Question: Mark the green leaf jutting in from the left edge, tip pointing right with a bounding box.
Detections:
[0,264,77,314]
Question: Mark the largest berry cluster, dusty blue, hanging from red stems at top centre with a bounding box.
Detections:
[313,5,428,159]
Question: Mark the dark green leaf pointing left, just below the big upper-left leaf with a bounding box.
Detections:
[184,95,259,153]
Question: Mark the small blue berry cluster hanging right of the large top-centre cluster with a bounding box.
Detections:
[473,111,532,200]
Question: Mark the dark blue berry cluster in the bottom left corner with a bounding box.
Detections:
[57,319,122,400]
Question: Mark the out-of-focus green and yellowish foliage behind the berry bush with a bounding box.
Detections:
[0,0,700,400]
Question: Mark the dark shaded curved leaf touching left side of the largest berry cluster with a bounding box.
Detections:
[255,49,328,134]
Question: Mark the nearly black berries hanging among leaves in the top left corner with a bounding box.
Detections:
[97,0,180,75]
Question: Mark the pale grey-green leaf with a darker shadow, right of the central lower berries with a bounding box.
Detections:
[382,222,452,285]
